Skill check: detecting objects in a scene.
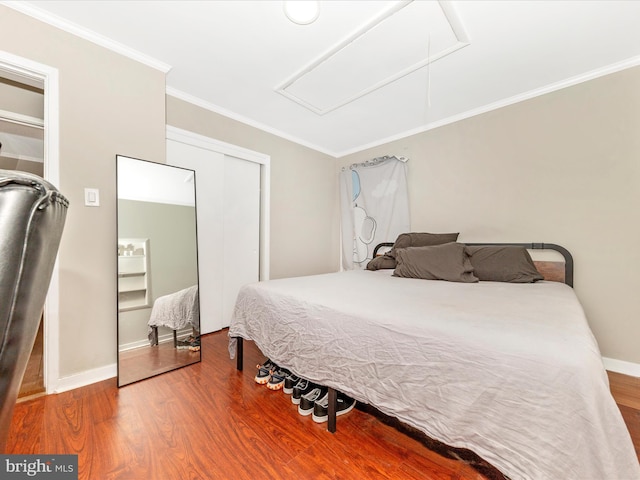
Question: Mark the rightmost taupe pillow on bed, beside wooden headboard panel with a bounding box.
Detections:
[466,245,544,283]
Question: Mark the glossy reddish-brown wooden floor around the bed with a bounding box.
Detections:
[5,331,640,480]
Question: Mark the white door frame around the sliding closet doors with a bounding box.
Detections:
[167,125,271,281]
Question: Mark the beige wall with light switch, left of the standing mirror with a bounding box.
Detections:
[0,6,165,377]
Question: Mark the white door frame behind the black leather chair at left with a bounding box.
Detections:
[0,50,60,394]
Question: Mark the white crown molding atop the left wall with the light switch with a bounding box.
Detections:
[0,0,171,73]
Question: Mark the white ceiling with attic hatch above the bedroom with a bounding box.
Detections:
[5,0,640,157]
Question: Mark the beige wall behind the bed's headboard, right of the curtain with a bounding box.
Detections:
[338,67,640,362]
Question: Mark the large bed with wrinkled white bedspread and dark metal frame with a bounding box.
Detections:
[229,241,640,480]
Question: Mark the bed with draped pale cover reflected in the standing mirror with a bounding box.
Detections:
[147,285,200,347]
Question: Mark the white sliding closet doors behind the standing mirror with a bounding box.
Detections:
[167,140,260,334]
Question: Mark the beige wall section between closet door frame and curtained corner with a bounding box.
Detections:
[167,96,339,278]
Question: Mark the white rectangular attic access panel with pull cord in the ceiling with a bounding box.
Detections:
[276,0,469,115]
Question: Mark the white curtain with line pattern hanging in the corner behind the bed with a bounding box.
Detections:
[340,156,409,270]
